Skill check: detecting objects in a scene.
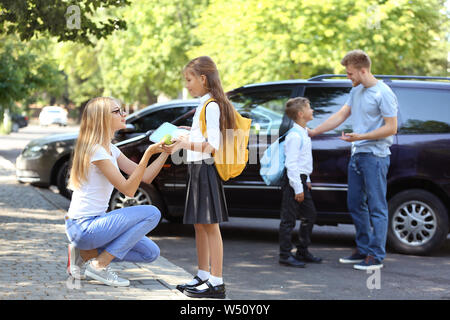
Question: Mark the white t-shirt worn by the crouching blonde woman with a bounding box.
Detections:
[68,144,121,219]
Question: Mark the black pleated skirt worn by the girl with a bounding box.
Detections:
[183,159,228,224]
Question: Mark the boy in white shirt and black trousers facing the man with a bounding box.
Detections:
[279,97,322,268]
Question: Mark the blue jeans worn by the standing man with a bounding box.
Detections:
[347,153,390,261]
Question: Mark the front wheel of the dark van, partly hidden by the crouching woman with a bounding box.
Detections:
[109,183,173,220]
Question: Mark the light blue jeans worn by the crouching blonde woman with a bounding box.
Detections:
[66,206,161,262]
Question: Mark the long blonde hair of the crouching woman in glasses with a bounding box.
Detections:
[68,97,121,190]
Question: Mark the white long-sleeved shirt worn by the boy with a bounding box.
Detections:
[285,123,313,194]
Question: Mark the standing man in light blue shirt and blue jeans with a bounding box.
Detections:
[309,50,398,270]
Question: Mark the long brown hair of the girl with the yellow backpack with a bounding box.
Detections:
[183,56,235,132]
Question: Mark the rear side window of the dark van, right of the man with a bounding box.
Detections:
[395,88,450,134]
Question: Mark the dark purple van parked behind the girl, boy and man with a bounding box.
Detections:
[16,75,450,254]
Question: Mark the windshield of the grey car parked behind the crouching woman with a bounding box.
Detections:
[131,106,192,132]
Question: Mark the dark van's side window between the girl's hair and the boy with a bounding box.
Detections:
[230,89,292,134]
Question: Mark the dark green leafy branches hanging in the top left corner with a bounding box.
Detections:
[0,0,129,44]
